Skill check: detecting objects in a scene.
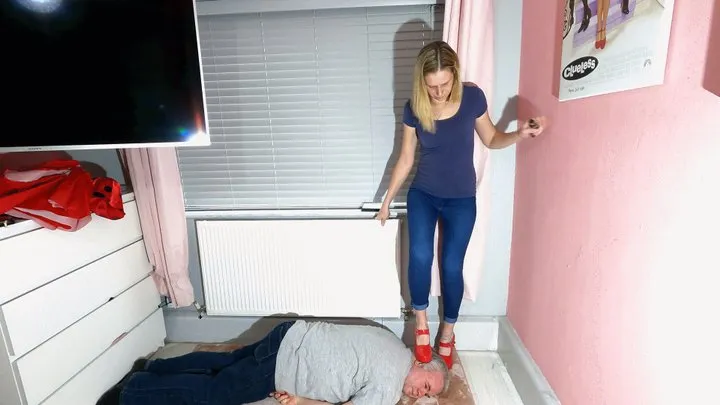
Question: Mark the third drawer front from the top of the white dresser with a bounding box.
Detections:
[16,277,160,405]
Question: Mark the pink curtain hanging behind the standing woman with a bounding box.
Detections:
[430,0,495,301]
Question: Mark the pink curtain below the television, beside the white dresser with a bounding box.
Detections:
[122,148,195,307]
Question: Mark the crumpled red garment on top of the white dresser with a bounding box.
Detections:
[0,160,125,231]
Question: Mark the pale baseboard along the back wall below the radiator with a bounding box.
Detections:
[165,310,499,351]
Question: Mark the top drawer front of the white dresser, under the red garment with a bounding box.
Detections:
[0,201,142,303]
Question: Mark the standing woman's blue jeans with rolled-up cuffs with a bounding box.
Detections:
[407,188,477,323]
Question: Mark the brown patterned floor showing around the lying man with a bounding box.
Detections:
[193,343,475,405]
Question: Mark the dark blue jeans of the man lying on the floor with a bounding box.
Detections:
[120,322,294,405]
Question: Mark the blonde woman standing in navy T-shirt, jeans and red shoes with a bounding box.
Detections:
[376,41,545,367]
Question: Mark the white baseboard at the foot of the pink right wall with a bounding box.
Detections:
[497,317,560,405]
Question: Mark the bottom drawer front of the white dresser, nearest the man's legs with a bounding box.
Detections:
[42,309,165,405]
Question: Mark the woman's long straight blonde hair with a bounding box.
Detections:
[410,41,462,133]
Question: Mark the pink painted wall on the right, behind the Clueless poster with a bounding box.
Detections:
[508,0,720,405]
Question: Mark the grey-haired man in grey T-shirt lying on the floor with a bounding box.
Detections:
[97,321,450,405]
